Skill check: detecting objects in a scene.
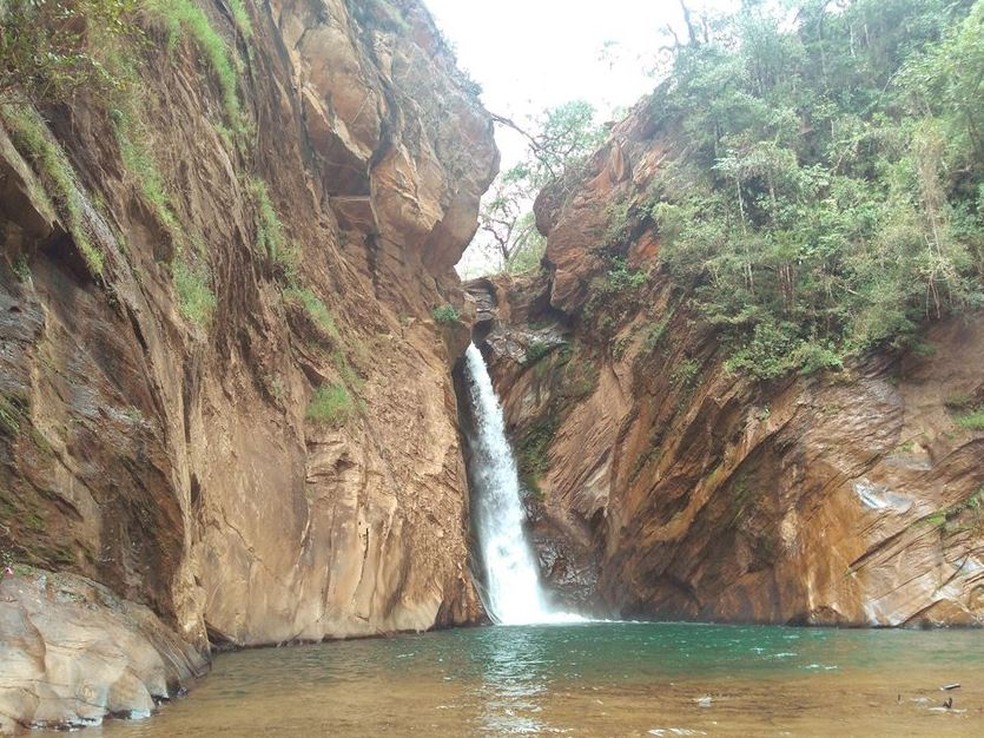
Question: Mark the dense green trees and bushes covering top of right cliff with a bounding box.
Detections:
[632,0,984,379]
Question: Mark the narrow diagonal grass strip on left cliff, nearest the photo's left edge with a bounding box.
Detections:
[0,104,103,277]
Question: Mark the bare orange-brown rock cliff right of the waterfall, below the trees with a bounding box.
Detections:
[469,95,984,626]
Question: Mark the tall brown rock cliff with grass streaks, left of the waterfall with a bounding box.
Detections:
[0,0,498,728]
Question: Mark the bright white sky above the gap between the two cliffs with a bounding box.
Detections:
[424,0,721,162]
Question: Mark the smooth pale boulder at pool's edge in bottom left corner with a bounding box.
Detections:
[0,567,208,734]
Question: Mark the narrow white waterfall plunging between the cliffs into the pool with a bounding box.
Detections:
[465,344,584,625]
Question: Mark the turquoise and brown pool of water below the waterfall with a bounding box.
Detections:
[94,623,984,737]
